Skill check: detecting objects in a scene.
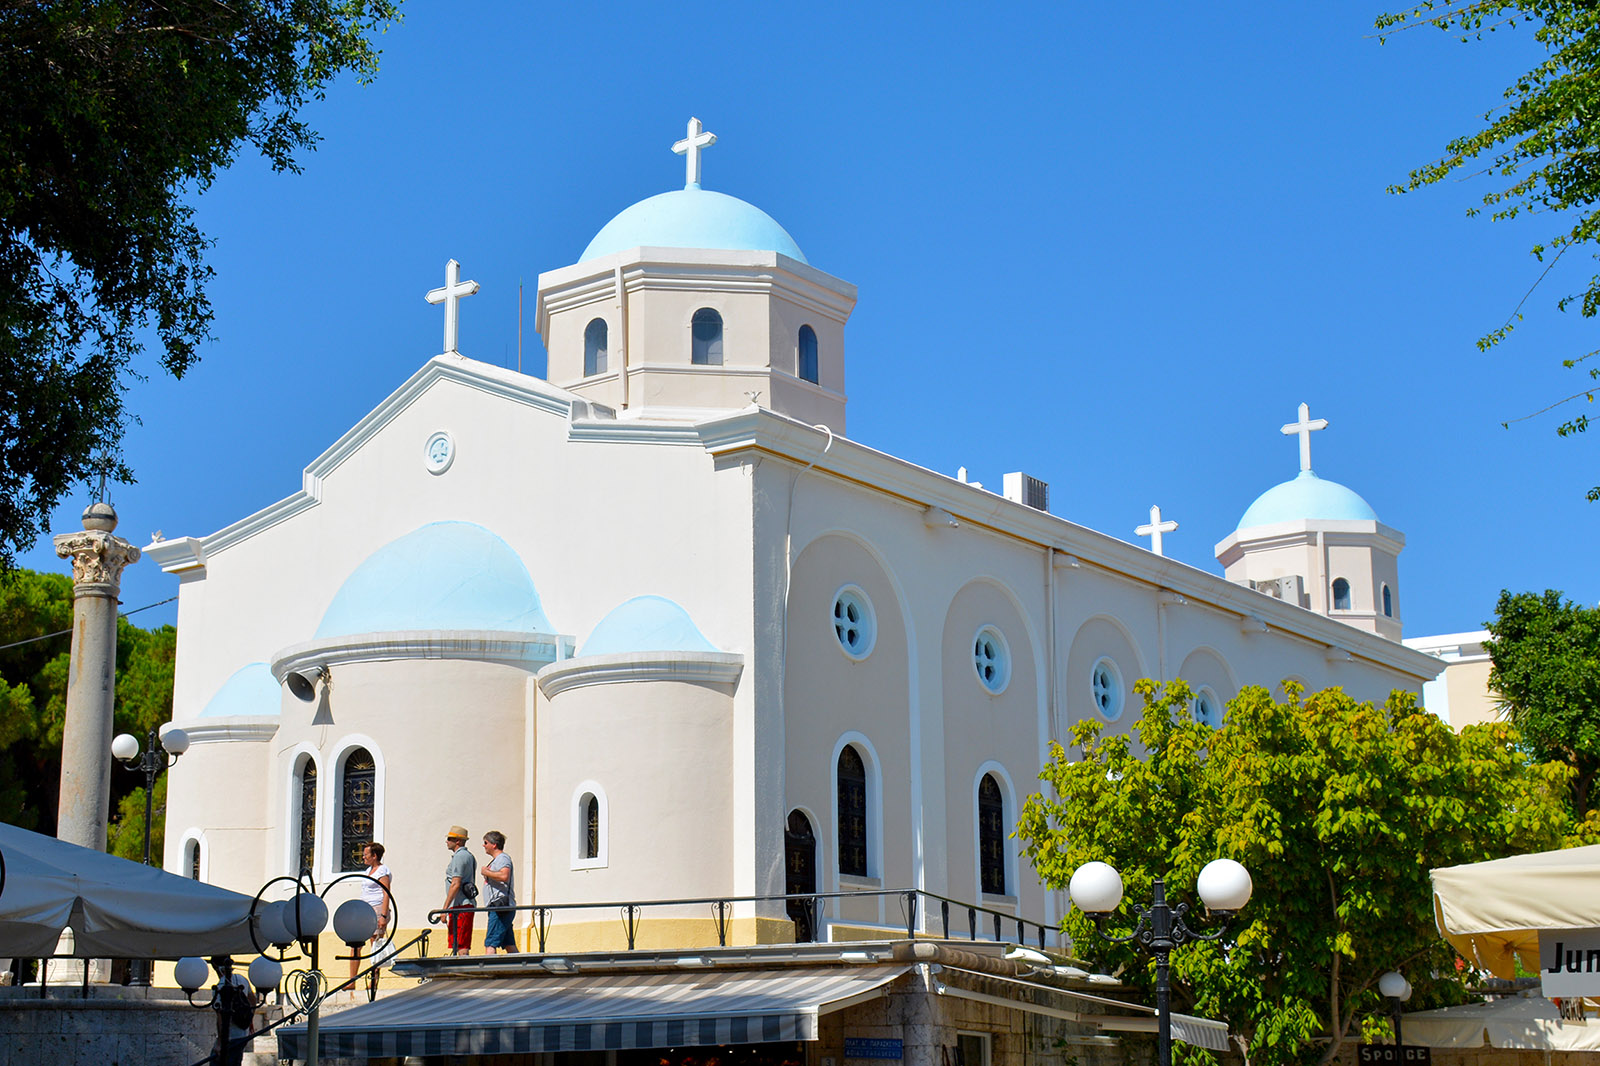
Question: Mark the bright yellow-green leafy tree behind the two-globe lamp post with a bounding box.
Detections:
[1016,680,1571,1066]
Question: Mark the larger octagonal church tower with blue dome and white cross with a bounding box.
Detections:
[534,118,856,435]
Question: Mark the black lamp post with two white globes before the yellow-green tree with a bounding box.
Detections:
[1067,860,1251,1066]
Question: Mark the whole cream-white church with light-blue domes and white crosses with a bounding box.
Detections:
[144,116,1440,952]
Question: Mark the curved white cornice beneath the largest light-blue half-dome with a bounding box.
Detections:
[272,629,574,683]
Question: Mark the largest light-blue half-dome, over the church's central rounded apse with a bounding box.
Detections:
[317,522,552,639]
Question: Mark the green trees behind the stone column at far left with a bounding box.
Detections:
[0,570,178,858]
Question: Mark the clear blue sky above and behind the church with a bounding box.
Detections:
[21,3,1600,635]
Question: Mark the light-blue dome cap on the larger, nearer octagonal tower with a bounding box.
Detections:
[578,186,806,262]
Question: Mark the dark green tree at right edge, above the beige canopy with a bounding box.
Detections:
[1485,589,1600,818]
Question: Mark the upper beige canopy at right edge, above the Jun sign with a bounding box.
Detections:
[1430,845,1600,980]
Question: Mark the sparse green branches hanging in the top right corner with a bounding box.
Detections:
[1378,0,1600,499]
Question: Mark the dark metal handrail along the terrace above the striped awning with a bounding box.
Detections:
[427,888,1059,954]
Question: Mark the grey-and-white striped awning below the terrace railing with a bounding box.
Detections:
[278,964,910,1060]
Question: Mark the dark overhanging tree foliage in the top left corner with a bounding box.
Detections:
[0,0,397,565]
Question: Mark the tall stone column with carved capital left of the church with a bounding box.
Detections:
[56,503,139,852]
